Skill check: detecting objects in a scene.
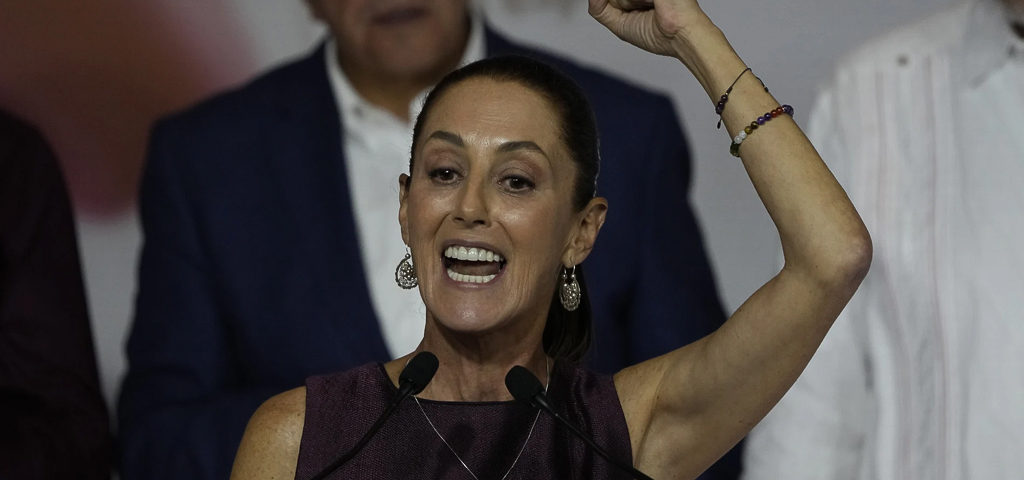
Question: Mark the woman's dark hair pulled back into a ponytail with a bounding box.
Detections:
[407,55,600,361]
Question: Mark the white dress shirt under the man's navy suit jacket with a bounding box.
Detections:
[325,15,484,357]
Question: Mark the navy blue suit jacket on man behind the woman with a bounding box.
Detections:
[119,32,724,480]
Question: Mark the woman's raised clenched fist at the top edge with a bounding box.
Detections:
[590,0,714,57]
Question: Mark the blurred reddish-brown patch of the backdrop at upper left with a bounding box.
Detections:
[0,0,257,216]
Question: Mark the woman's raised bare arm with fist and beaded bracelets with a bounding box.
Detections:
[590,0,871,478]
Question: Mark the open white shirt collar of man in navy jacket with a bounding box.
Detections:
[324,11,485,125]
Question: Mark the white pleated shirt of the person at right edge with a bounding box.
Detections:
[745,0,1024,480]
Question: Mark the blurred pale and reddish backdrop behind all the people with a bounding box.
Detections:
[0,0,953,407]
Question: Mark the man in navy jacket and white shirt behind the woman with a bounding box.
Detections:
[119,0,738,478]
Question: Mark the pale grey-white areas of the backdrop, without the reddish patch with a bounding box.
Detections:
[78,0,954,407]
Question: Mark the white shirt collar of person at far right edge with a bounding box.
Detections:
[961,0,1024,85]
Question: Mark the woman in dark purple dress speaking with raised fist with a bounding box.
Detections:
[231,0,871,474]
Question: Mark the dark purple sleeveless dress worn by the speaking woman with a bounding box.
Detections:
[295,362,632,480]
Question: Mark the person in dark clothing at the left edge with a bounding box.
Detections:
[0,111,112,479]
